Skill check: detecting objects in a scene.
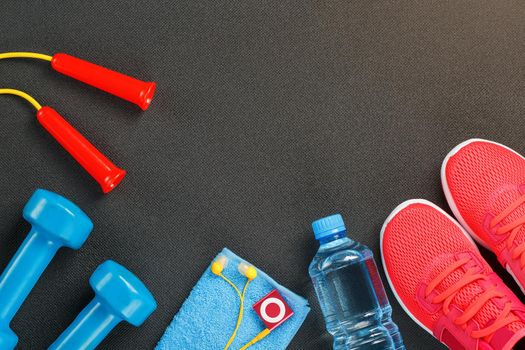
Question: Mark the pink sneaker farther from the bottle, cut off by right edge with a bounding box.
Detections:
[441,139,525,291]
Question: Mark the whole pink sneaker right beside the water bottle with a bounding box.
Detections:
[381,200,525,350]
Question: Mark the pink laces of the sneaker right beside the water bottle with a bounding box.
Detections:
[425,257,518,338]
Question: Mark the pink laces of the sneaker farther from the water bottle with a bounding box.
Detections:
[490,195,525,269]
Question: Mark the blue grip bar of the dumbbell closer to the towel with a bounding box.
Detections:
[49,297,122,350]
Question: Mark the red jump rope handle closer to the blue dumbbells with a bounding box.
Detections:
[37,107,126,193]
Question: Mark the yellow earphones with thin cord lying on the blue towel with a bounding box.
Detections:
[211,255,257,350]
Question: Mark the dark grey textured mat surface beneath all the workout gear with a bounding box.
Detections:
[0,0,525,350]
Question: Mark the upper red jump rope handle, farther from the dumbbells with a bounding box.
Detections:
[51,53,155,110]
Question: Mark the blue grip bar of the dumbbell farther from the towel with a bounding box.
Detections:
[0,228,60,326]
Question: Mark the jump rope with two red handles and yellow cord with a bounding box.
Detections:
[0,52,156,193]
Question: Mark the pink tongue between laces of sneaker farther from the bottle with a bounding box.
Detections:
[490,185,525,251]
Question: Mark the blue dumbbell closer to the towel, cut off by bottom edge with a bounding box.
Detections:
[49,260,157,350]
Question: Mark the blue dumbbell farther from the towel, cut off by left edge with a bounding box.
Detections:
[0,190,93,350]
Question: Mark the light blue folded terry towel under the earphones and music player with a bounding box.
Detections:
[156,248,310,350]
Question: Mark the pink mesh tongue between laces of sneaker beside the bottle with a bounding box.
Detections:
[430,255,525,334]
